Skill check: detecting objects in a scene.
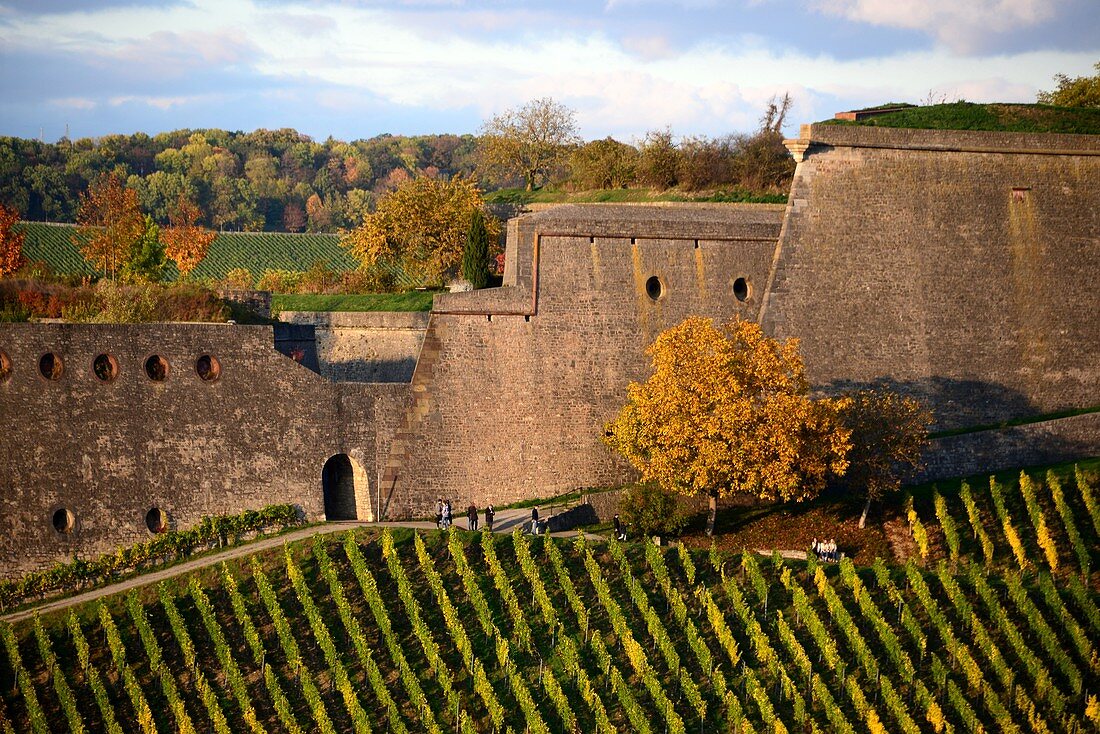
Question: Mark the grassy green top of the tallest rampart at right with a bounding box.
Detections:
[820,102,1100,135]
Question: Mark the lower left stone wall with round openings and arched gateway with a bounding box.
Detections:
[0,324,407,576]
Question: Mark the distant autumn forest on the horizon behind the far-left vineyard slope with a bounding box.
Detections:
[0,129,476,232]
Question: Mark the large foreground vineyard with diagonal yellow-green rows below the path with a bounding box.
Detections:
[0,515,1100,734]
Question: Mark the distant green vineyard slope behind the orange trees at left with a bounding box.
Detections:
[20,222,358,278]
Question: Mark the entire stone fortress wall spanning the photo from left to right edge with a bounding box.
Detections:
[0,125,1100,574]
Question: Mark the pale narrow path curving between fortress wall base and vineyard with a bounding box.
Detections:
[0,510,601,624]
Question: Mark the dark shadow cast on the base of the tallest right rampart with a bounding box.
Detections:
[818,377,1040,432]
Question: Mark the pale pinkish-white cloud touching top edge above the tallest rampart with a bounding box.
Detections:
[814,0,1059,53]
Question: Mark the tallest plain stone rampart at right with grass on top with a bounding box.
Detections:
[759,125,1100,428]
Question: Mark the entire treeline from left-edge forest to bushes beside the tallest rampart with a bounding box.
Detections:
[0,120,793,232]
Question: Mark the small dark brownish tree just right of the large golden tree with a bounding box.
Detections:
[840,390,932,527]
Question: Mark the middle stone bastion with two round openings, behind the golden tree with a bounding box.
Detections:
[382,206,782,516]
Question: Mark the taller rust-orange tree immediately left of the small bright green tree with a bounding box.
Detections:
[73,173,145,280]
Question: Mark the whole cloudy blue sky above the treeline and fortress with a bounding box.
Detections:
[0,0,1100,142]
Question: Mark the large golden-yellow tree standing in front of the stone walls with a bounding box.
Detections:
[604,317,850,534]
